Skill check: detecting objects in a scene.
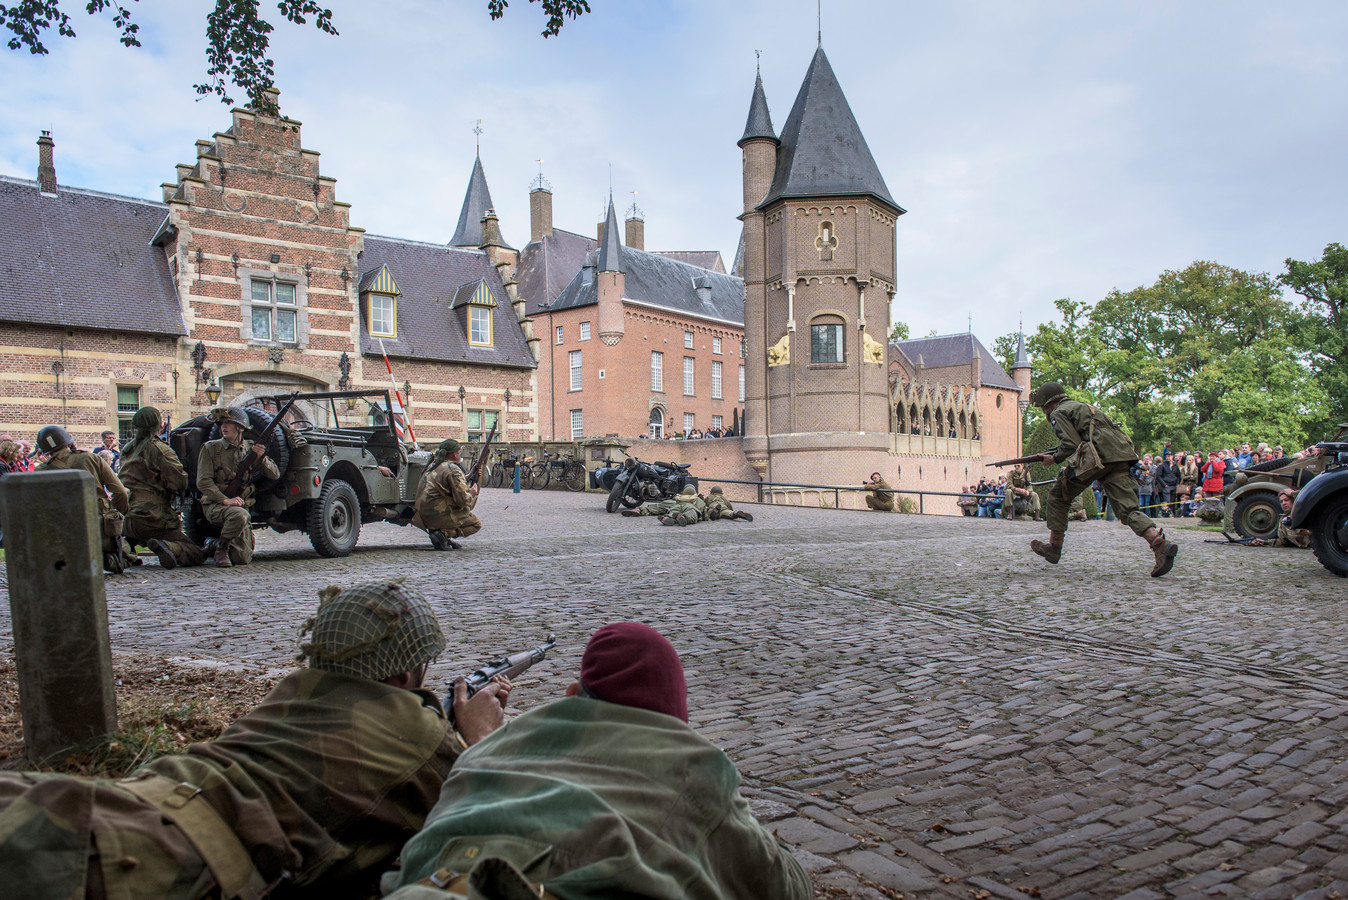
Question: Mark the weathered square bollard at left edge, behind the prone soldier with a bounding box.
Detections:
[0,469,117,763]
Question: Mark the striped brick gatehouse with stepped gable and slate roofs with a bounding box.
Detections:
[0,91,538,445]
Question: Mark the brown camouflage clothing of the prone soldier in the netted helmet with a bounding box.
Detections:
[0,668,460,900]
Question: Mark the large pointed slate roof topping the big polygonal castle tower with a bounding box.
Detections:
[758,47,906,213]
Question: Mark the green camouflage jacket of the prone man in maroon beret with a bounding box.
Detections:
[384,697,811,900]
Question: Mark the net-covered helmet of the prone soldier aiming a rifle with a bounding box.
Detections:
[295,581,445,682]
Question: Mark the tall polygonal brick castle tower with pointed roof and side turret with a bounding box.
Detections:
[740,47,905,482]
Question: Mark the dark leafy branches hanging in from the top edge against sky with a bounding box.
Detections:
[0,0,590,115]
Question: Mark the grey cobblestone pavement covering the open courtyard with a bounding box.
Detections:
[0,490,1348,900]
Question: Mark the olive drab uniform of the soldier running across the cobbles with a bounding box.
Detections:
[1047,399,1157,535]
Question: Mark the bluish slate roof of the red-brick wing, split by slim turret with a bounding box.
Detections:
[553,247,744,326]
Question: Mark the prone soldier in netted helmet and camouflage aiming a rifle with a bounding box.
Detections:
[0,582,510,900]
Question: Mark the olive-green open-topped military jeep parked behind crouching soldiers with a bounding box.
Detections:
[170,391,430,556]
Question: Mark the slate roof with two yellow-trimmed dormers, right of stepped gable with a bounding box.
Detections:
[360,234,537,369]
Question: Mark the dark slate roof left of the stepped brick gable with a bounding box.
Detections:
[0,175,187,335]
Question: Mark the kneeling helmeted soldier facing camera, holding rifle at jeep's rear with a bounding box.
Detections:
[197,407,280,569]
